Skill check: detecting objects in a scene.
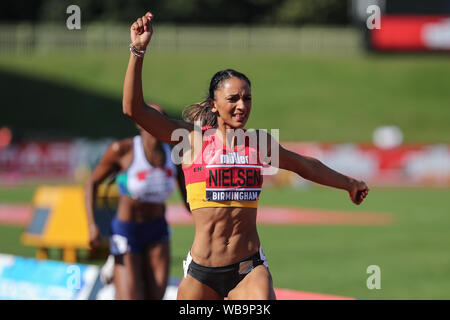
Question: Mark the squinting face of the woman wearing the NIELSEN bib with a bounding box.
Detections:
[211,77,252,129]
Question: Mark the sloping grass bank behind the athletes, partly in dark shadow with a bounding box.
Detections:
[0,50,450,142]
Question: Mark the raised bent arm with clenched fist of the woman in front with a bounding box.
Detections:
[122,12,193,144]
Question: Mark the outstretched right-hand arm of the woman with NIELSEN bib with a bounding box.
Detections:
[268,135,369,205]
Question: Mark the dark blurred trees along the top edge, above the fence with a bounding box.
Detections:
[0,0,349,25]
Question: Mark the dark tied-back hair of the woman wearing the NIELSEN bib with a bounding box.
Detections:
[183,69,251,127]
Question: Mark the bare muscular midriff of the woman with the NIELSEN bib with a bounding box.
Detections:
[191,207,260,267]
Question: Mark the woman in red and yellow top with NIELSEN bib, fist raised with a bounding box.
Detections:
[123,12,369,300]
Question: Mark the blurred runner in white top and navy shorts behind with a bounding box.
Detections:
[86,104,186,300]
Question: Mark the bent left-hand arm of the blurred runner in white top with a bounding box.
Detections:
[85,141,121,248]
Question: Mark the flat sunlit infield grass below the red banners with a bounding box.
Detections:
[0,187,450,299]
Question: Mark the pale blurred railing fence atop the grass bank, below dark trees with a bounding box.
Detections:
[0,24,363,54]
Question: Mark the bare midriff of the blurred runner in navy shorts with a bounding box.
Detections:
[117,195,166,223]
